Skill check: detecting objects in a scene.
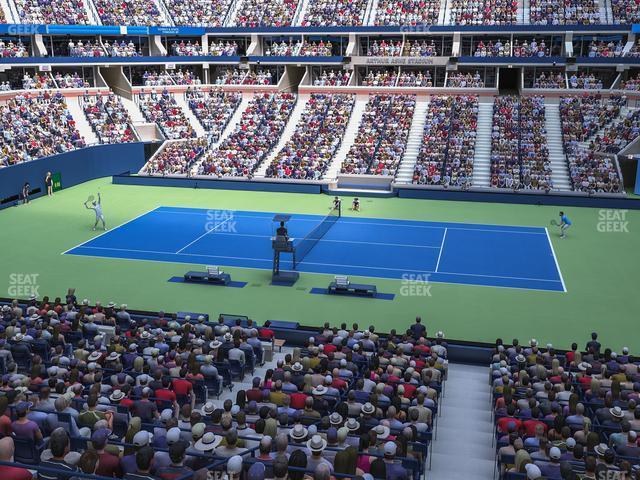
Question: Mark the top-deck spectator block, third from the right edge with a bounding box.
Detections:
[449,0,518,25]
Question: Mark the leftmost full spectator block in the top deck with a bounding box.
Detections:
[15,0,91,25]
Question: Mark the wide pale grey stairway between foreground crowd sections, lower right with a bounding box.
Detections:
[427,364,495,480]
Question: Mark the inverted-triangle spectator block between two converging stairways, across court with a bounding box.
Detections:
[185,87,242,142]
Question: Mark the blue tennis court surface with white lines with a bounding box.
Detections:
[64,207,566,292]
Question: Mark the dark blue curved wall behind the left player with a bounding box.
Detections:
[0,142,145,208]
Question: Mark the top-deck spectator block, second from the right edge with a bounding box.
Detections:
[529,0,604,25]
